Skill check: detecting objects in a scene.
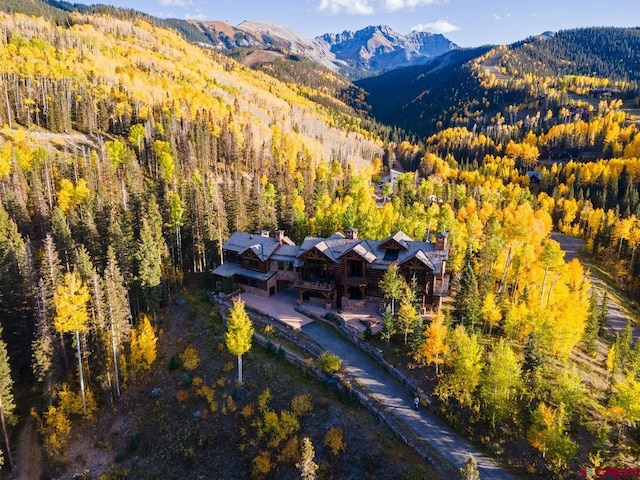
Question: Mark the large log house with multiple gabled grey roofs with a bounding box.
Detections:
[213,229,449,311]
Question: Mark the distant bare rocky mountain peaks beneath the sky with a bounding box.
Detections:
[190,20,458,77]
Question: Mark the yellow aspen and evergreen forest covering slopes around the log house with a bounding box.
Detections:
[0,4,640,478]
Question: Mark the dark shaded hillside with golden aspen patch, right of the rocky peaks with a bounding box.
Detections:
[355,28,640,135]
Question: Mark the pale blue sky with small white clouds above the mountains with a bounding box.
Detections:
[70,0,640,47]
